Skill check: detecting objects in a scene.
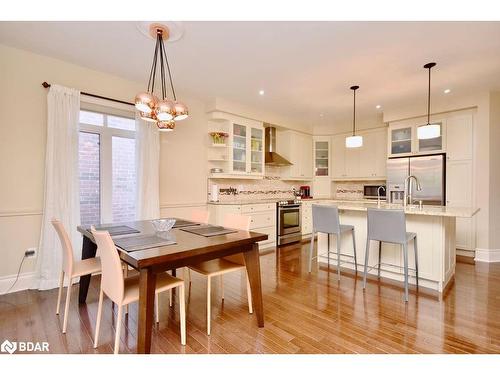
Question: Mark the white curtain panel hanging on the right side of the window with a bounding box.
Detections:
[135,117,160,220]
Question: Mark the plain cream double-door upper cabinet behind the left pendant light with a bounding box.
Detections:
[331,128,387,180]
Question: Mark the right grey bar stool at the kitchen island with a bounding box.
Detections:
[363,208,418,302]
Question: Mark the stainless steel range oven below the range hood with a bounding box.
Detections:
[276,199,302,246]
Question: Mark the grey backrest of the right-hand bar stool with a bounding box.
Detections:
[367,208,406,244]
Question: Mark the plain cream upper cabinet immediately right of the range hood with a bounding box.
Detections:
[276,130,313,181]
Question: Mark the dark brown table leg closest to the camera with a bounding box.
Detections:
[137,268,156,354]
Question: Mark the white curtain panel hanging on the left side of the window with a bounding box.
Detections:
[35,85,82,290]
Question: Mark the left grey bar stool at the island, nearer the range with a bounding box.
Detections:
[309,204,358,280]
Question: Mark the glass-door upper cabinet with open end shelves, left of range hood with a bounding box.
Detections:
[208,112,264,178]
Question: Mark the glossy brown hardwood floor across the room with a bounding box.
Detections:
[0,244,500,353]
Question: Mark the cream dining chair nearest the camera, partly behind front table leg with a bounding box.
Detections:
[92,229,186,354]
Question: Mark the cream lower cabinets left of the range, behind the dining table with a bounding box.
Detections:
[208,203,276,250]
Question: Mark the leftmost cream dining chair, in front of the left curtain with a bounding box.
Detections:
[51,219,101,333]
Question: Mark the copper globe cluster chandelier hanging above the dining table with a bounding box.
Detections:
[134,24,188,131]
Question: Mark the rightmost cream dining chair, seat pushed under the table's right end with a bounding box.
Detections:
[186,214,253,335]
